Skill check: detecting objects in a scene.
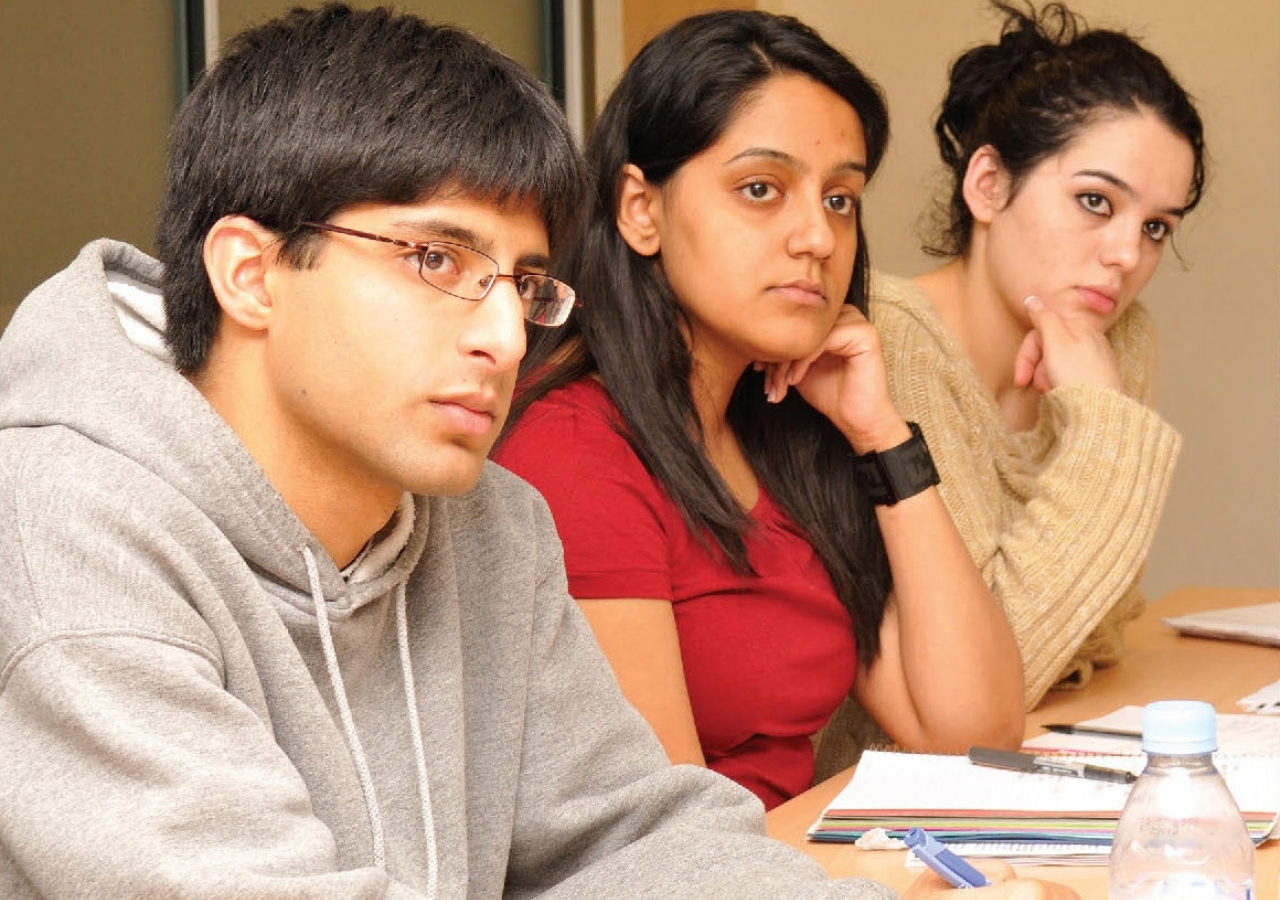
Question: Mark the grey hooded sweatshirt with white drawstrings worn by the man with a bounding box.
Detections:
[0,241,891,900]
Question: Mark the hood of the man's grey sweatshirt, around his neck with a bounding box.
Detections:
[0,241,429,612]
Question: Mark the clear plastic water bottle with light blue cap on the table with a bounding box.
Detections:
[1110,700,1253,900]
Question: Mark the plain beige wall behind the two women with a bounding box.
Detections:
[598,0,1280,597]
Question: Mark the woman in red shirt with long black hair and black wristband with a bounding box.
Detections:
[497,12,1023,807]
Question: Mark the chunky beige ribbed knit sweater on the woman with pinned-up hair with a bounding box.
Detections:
[872,277,1180,708]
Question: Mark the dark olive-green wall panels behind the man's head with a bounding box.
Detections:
[0,0,547,328]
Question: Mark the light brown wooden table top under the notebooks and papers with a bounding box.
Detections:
[768,588,1280,900]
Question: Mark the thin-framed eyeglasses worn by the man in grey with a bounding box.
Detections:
[301,221,577,328]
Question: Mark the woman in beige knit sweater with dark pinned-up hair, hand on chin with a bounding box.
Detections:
[870,4,1204,708]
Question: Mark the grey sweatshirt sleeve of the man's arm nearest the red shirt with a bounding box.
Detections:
[494,499,896,900]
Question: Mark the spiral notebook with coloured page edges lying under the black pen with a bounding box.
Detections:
[808,750,1280,862]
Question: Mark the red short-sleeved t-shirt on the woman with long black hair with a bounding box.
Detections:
[495,378,856,808]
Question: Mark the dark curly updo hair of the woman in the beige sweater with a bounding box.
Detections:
[925,0,1204,256]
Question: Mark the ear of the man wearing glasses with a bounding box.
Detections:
[205,215,279,330]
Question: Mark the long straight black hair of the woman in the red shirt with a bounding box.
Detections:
[511,10,892,662]
